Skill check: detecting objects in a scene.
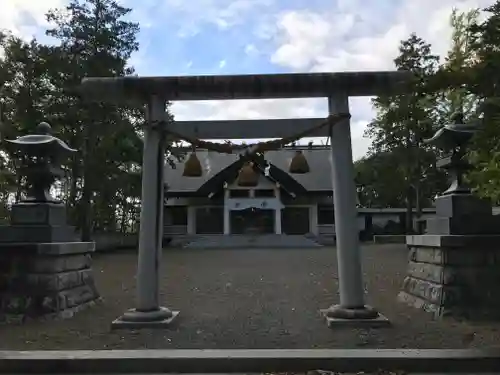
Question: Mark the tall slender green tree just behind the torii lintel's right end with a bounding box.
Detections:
[365,34,439,232]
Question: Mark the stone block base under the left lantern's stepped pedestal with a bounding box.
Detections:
[0,242,99,323]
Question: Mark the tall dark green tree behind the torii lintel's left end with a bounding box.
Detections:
[47,0,142,240]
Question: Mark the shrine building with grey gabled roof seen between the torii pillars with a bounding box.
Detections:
[164,145,340,236]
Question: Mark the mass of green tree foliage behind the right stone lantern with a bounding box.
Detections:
[358,6,500,214]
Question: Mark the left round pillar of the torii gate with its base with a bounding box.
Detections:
[112,96,178,329]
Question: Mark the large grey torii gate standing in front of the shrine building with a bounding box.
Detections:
[81,72,410,329]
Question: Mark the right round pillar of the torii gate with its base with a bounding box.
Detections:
[325,93,385,326]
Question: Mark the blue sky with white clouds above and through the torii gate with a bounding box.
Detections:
[0,0,493,159]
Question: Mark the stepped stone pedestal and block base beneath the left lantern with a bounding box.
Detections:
[0,124,99,323]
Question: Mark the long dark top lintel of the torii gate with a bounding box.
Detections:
[80,71,411,102]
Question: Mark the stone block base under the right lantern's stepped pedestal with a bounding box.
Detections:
[399,235,500,319]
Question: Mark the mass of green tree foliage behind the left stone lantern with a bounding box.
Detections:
[0,0,167,235]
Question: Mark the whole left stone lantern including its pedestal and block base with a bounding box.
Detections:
[0,123,99,323]
